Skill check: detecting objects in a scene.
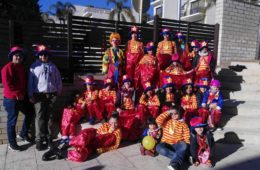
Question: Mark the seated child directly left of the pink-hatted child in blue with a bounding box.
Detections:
[196,78,209,123]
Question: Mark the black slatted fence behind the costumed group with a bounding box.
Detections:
[0,15,219,82]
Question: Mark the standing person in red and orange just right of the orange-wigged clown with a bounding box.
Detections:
[125,26,144,80]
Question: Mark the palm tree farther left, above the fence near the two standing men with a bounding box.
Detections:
[49,1,76,24]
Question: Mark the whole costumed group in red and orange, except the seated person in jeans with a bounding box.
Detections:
[61,26,223,166]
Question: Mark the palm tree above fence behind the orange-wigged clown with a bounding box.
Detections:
[107,0,135,22]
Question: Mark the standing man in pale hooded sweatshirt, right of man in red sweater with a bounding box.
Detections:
[28,45,62,150]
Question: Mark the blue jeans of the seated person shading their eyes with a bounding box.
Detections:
[156,142,188,166]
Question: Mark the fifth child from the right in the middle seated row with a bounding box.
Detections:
[138,82,160,125]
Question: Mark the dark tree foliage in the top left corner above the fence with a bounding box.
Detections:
[0,0,41,21]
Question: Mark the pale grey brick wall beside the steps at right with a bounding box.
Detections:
[216,0,260,64]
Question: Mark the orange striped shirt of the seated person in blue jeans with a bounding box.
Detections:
[156,111,190,144]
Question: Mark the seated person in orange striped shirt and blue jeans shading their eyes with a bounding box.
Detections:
[156,106,190,170]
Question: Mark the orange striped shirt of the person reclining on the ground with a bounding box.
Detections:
[97,123,122,153]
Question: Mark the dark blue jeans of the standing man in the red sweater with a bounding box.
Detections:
[3,97,33,145]
